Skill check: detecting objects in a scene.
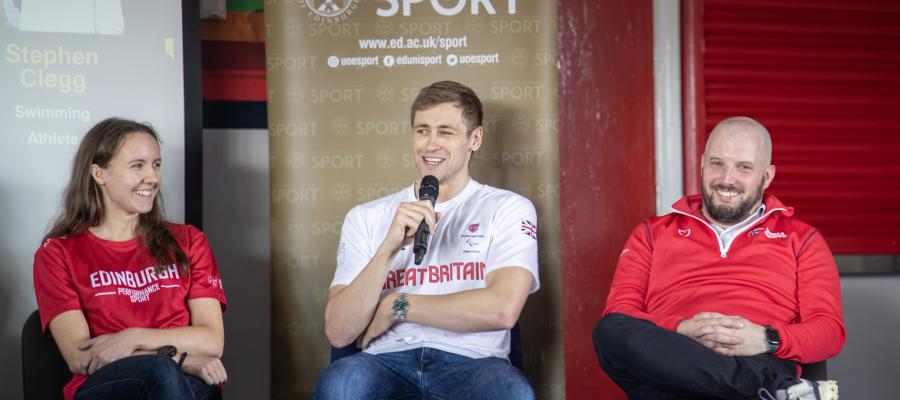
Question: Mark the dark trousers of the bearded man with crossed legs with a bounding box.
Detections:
[594,314,797,400]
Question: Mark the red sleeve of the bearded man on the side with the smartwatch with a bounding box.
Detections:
[772,231,847,363]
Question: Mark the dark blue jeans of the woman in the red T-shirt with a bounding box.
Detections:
[75,355,219,400]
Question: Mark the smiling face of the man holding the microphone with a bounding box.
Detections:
[412,103,484,201]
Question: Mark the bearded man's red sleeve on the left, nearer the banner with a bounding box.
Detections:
[603,222,685,331]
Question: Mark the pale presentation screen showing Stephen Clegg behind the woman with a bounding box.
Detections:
[0,0,185,332]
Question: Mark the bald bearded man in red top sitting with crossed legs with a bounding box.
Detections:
[593,117,846,400]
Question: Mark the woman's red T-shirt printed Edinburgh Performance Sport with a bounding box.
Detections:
[34,224,225,399]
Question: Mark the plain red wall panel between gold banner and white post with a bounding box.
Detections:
[559,0,655,399]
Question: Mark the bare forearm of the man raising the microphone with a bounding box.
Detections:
[325,245,395,347]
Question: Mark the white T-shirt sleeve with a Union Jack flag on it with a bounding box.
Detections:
[484,195,541,293]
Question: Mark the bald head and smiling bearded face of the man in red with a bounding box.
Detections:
[701,117,775,227]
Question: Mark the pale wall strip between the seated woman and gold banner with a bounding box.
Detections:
[203,129,274,399]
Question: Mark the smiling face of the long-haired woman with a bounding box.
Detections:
[91,132,162,220]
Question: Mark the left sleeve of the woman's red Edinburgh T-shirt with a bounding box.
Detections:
[34,239,81,333]
